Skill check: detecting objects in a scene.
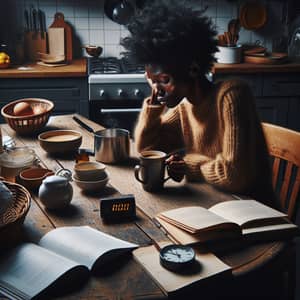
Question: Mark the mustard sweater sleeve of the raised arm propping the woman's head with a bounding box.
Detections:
[134,99,183,152]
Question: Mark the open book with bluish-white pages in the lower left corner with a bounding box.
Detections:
[0,226,138,299]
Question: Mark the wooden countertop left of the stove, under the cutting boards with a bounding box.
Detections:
[0,58,87,78]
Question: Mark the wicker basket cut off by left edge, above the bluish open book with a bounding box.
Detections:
[0,181,31,248]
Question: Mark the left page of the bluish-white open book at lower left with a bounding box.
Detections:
[0,243,87,299]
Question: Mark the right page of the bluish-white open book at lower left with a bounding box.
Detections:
[39,226,138,270]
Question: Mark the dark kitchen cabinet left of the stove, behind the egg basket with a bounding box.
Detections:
[0,77,89,122]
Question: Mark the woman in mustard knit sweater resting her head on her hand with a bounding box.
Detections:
[122,0,273,205]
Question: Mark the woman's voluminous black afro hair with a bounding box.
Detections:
[121,0,218,74]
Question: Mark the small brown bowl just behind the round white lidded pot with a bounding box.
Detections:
[19,168,54,190]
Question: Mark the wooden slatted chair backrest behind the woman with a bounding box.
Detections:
[262,123,300,221]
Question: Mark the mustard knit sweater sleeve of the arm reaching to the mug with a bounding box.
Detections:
[185,81,256,192]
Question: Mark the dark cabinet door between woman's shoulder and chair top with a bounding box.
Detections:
[256,97,289,127]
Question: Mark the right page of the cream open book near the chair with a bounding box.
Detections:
[209,200,287,229]
